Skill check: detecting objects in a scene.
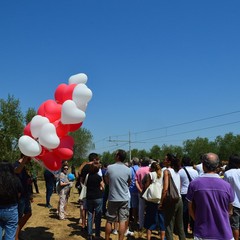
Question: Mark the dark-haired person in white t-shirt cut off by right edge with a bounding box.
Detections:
[224,155,240,240]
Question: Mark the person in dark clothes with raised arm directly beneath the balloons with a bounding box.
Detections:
[14,154,33,240]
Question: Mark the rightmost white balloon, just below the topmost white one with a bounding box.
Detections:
[72,83,92,110]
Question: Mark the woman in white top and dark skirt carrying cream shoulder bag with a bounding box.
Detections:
[143,162,165,240]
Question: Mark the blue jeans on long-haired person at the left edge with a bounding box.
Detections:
[0,204,18,240]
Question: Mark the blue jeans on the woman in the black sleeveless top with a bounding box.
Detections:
[87,198,103,237]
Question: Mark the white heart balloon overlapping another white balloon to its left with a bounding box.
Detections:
[39,123,60,149]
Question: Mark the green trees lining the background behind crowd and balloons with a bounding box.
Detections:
[0,95,240,166]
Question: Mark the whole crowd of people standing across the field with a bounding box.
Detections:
[0,149,240,240]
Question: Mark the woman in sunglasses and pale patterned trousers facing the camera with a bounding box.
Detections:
[58,165,71,220]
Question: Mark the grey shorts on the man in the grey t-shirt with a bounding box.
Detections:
[106,201,129,222]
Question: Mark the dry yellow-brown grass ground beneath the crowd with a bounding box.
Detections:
[20,181,194,240]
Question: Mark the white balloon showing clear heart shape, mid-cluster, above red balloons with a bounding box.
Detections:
[61,100,86,124]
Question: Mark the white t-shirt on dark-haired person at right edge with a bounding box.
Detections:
[224,168,240,208]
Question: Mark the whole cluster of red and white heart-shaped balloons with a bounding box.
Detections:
[18,73,92,171]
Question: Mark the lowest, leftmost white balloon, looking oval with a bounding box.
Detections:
[18,135,42,157]
